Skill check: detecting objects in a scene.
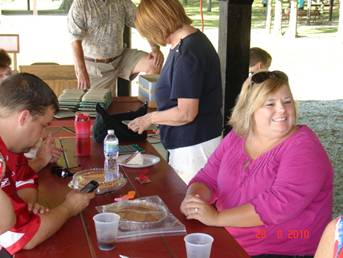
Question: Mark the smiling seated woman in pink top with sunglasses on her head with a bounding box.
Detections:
[181,71,333,258]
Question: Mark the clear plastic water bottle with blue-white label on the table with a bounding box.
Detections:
[104,130,120,182]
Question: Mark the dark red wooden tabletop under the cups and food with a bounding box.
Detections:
[15,97,249,258]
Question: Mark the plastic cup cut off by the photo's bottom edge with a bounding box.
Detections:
[184,233,213,258]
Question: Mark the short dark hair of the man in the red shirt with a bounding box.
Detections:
[0,73,59,116]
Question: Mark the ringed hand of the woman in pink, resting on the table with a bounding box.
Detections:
[181,195,219,226]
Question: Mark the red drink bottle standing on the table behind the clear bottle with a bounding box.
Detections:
[74,112,91,156]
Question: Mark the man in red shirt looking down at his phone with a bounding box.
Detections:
[0,73,94,254]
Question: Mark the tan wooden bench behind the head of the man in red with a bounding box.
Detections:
[19,63,77,96]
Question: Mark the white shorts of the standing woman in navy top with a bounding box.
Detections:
[168,136,222,184]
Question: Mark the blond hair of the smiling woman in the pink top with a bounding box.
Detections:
[229,71,297,136]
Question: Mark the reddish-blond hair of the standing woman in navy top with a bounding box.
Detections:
[135,0,192,46]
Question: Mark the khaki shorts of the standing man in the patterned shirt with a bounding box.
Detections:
[85,48,147,96]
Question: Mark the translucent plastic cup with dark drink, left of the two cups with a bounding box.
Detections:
[93,212,120,251]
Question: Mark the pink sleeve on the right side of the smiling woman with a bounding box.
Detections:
[251,130,332,224]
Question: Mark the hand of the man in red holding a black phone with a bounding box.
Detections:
[62,190,95,216]
